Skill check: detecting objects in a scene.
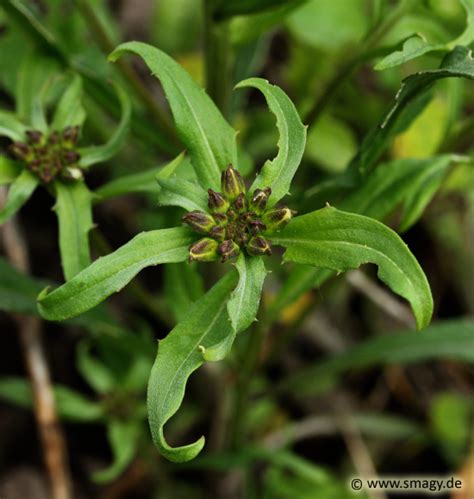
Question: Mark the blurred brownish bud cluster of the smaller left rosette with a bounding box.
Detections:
[10,126,82,184]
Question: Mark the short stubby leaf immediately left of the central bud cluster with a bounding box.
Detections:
[157,178,208,211]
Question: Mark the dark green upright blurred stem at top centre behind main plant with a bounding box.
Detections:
[203,0,232,117]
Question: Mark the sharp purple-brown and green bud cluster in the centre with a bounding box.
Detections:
[183,165,295,262]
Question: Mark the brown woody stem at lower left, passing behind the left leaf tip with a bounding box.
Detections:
[0,188,72,499]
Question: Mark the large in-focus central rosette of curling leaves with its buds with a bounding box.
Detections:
[39,42,433,462]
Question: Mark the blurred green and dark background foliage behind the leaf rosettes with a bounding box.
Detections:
[0,0,474,499]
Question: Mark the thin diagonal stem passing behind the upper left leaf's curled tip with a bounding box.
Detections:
[75,0,180,145]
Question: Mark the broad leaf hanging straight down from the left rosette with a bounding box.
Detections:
[54,181,93,281]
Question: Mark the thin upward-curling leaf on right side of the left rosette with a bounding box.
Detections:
[79,85,132,168]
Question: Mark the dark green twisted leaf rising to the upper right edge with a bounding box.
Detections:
[349,47,474,175]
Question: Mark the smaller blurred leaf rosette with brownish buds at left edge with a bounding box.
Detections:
[0,73,131,280]
